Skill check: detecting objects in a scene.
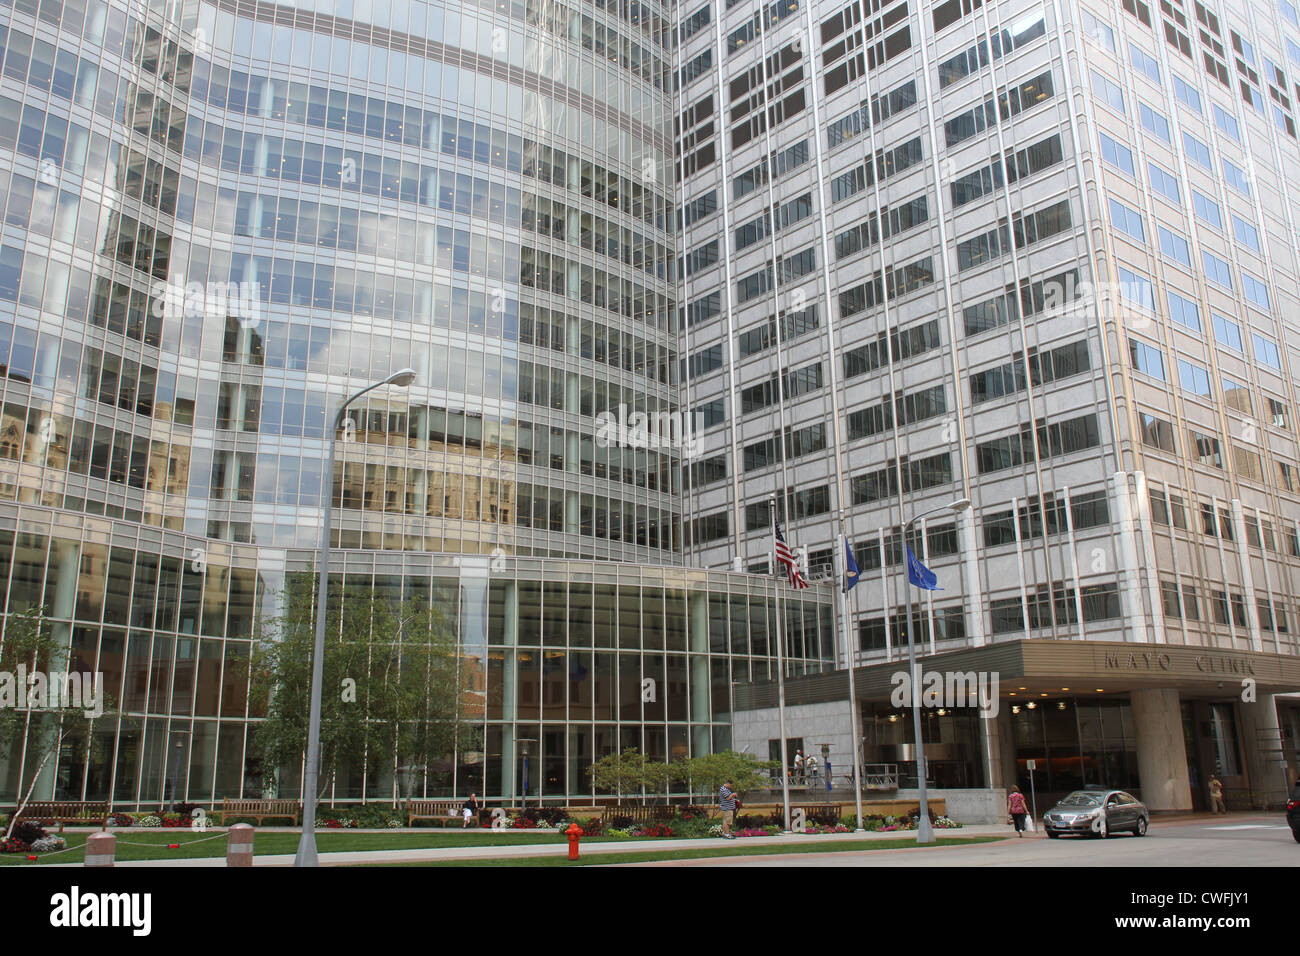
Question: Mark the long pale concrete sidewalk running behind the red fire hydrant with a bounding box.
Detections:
[47,823,1011,868]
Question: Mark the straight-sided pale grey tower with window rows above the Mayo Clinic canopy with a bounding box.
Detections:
[677,0,1300,662]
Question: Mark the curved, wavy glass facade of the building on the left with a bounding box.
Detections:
[0,0,831,806]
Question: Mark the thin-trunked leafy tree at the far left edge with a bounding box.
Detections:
[0,606,112,839]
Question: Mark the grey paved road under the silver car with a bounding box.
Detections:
[623,814,1300,866]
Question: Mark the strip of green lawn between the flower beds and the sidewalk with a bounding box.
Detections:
[0,830,644,866]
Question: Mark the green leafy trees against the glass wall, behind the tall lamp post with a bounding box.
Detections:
[252,575,477,806]
